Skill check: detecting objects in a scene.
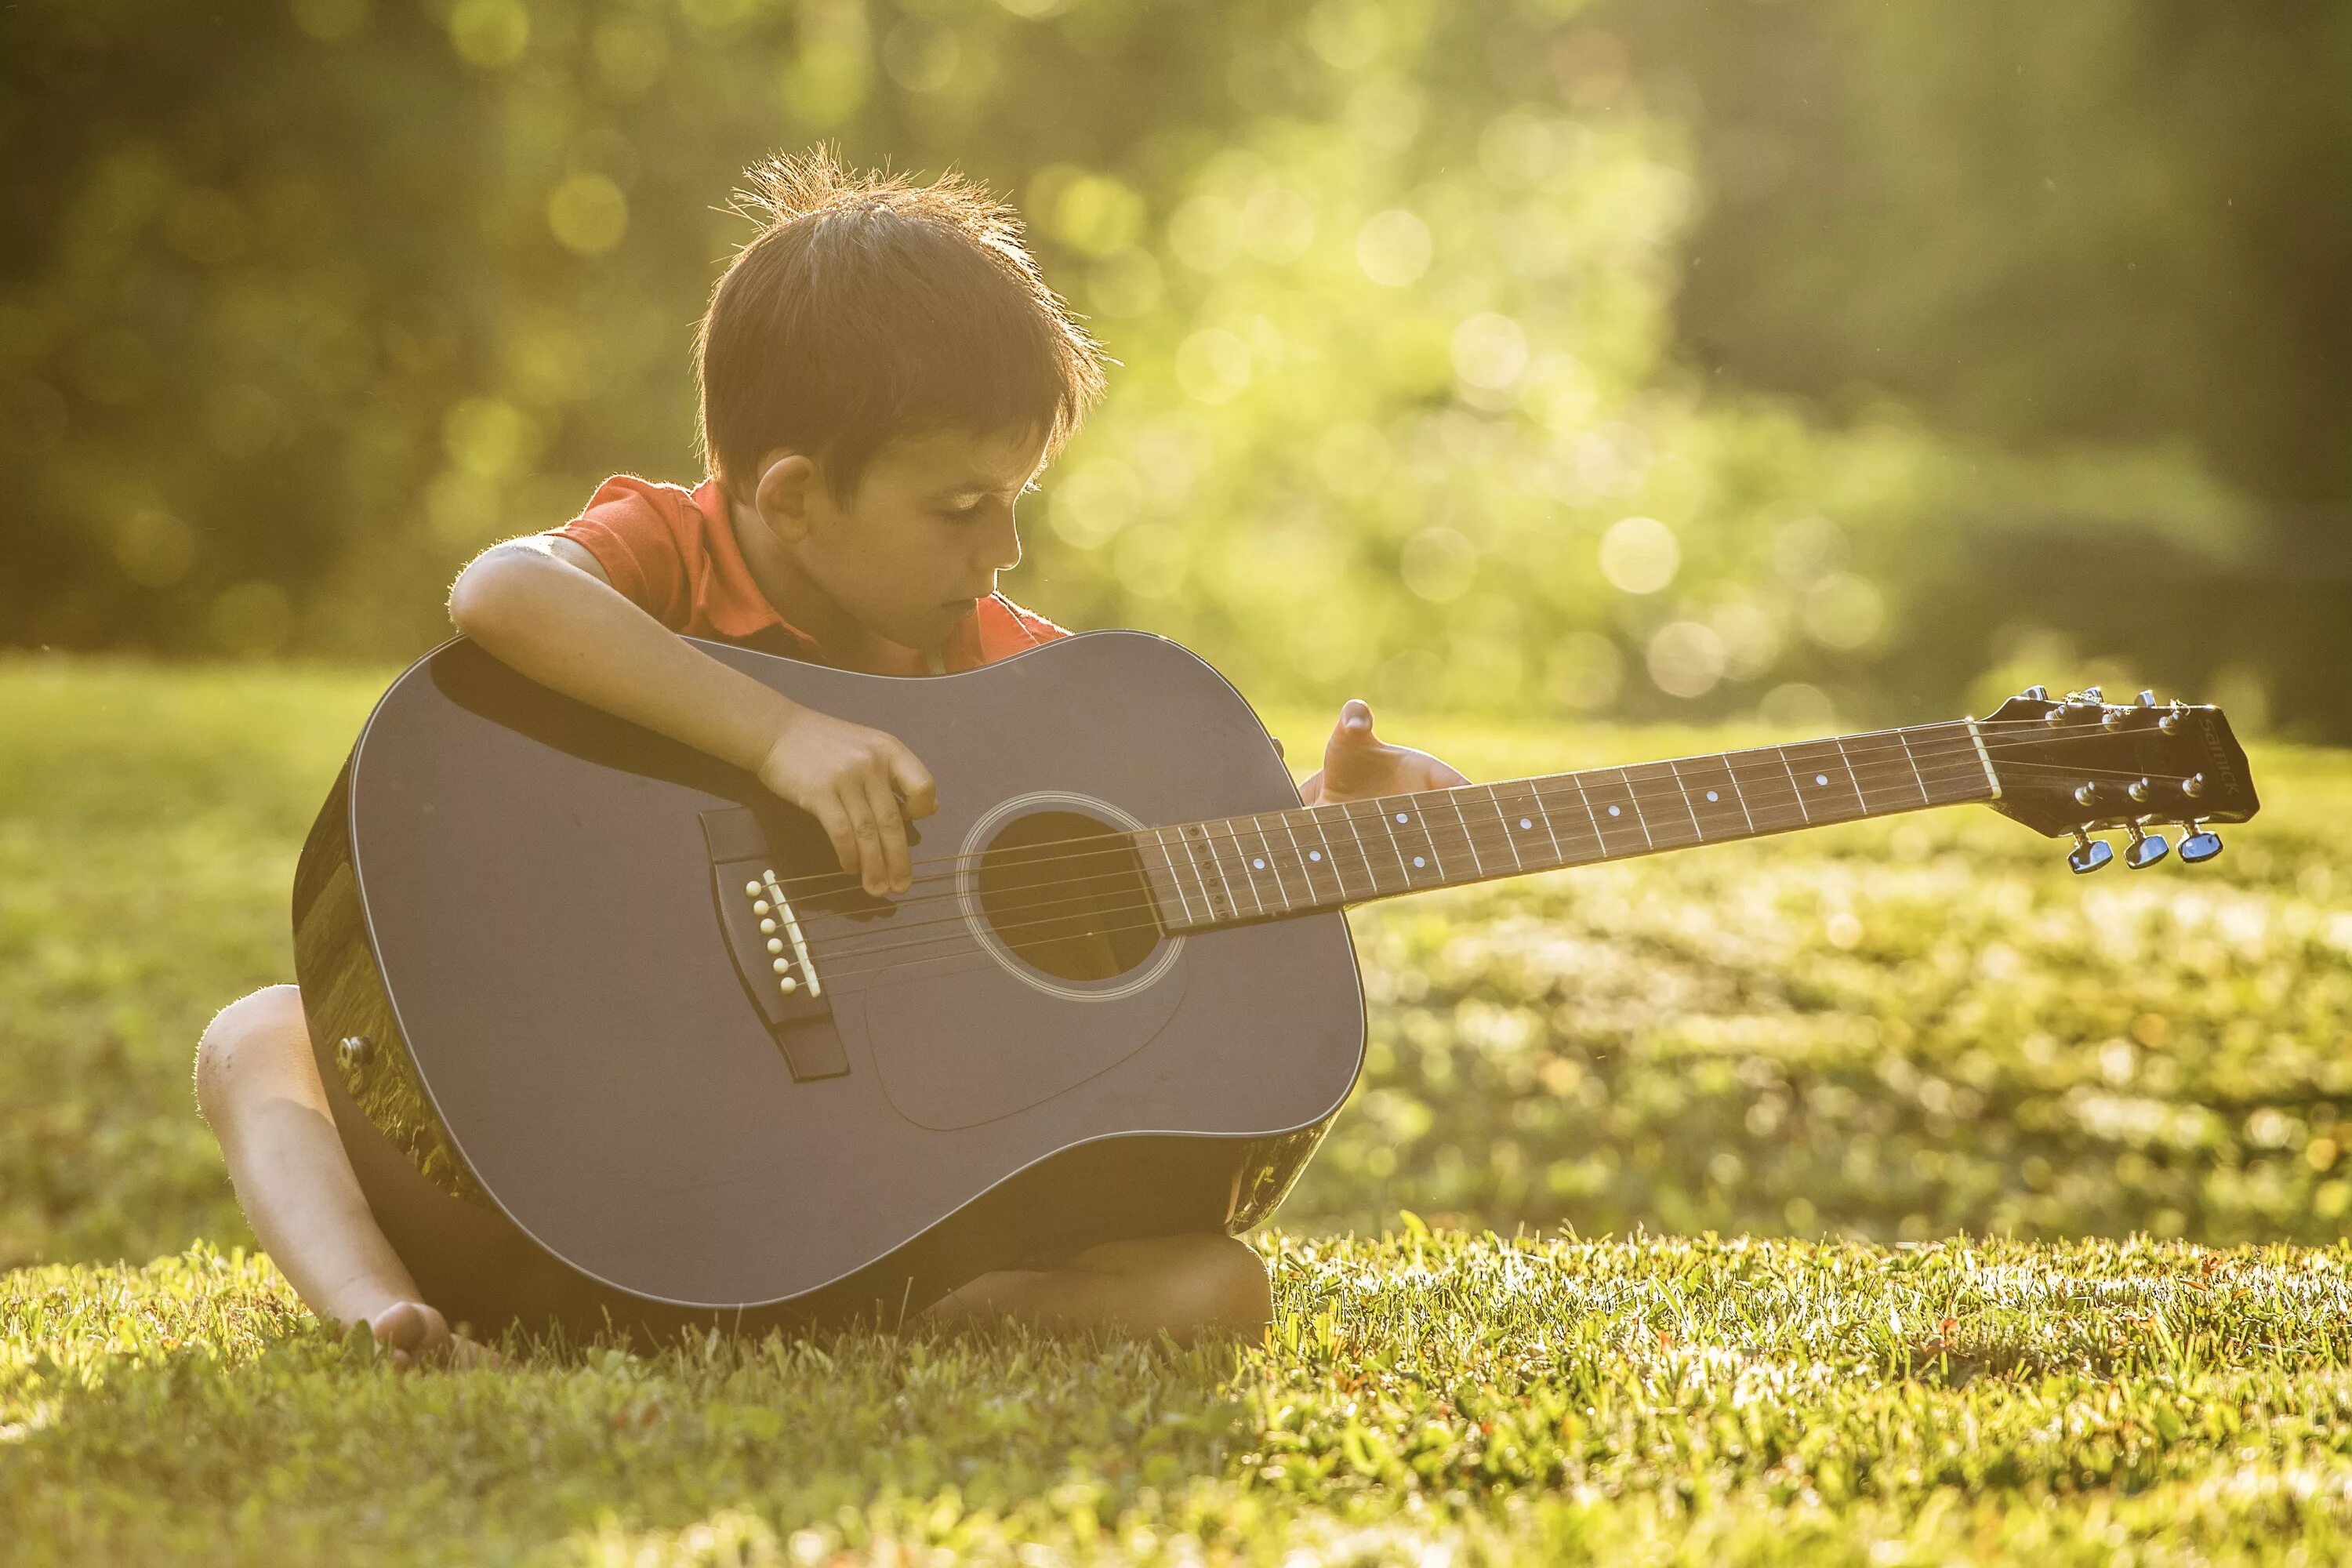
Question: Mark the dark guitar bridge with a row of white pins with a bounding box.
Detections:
[701,806,849,1081]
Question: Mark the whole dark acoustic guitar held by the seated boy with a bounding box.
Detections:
[294,630,2258,1340]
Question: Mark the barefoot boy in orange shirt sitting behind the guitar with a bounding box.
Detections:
[195,153,1468,1366]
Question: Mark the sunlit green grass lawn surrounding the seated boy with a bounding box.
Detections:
[0,661,2352,1563]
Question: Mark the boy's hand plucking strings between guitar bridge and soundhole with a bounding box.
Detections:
[760,708,938,898]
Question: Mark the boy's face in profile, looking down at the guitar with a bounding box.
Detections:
[779,430,1044,649]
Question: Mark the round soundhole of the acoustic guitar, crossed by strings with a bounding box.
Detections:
[978,811,1160,980]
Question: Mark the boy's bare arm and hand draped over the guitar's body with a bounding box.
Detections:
[449,534,936,895]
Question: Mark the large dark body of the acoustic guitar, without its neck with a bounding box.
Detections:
[294,633,1364,1342]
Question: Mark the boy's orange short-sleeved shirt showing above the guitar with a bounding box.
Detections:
[548,475,1070,675]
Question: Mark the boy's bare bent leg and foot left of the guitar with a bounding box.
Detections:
[195,985,485,1366]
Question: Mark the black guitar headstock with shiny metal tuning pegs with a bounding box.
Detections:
[1978,687,2263,872]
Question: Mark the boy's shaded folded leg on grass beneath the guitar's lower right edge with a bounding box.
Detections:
[924,1234,1275,1345]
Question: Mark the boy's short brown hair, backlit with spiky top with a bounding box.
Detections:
[696,148,1103,501]
